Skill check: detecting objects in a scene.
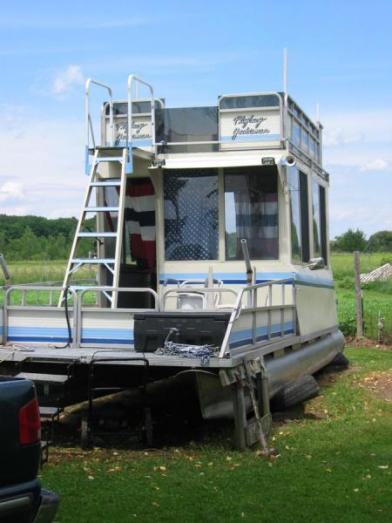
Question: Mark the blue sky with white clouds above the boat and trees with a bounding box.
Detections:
[0,0,392,238]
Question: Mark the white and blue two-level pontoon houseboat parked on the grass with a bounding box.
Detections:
[0,75,344,448]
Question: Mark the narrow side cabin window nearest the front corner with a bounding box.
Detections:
[288,167,309,263]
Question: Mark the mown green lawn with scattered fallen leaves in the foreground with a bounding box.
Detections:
[42,349,392,523]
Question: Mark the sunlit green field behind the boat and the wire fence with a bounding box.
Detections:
[0,253,392,343]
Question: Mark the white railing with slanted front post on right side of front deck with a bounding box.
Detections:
[219,278,296,358]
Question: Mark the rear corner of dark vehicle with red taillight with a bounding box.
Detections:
[0,377,59,523]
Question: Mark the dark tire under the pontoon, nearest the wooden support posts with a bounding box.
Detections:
[271,374,320,411]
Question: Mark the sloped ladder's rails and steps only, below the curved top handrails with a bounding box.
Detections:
[59,147,128,309]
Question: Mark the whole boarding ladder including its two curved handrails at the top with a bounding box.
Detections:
[58,74,157,309]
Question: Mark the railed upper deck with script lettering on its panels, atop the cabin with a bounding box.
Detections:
[101,92,322,169]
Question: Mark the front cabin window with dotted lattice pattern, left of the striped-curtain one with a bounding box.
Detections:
[164,169,218,260]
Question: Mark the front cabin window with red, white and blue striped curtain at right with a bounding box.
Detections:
[224,167,279,260]
